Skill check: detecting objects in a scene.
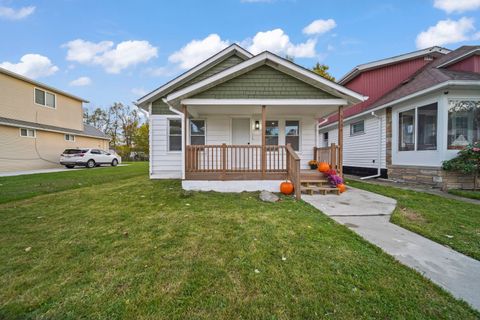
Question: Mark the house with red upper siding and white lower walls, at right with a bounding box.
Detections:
[319,46,480,188]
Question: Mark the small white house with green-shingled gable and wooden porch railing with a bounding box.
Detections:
[137,44,366,196]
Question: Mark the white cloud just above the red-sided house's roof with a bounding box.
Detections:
[416,17,475,49]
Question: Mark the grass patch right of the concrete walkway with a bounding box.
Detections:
[348,181,480,260]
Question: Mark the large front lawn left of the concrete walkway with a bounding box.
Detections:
[0,171,480,319]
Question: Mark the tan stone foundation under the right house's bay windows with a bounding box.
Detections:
[388,165,480,190]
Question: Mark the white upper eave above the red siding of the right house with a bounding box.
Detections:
[338,46,451,85]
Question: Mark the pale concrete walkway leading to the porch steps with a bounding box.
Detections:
[302,188,480,311]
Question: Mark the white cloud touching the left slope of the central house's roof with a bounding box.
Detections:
[168,34,229,69]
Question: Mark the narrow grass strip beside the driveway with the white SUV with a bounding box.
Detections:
[0,162,148,204]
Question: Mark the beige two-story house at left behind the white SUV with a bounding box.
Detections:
[0,68,109,172]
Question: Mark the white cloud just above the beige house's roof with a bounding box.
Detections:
[0,53,59,79]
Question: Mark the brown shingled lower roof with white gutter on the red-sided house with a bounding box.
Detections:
[323,46,480,127]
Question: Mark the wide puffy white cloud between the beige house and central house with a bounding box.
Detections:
[63,39,158,73]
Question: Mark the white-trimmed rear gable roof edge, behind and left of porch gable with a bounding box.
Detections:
[136,43,253,108]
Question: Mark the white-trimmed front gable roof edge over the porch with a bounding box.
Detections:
[166,51,367,104]
